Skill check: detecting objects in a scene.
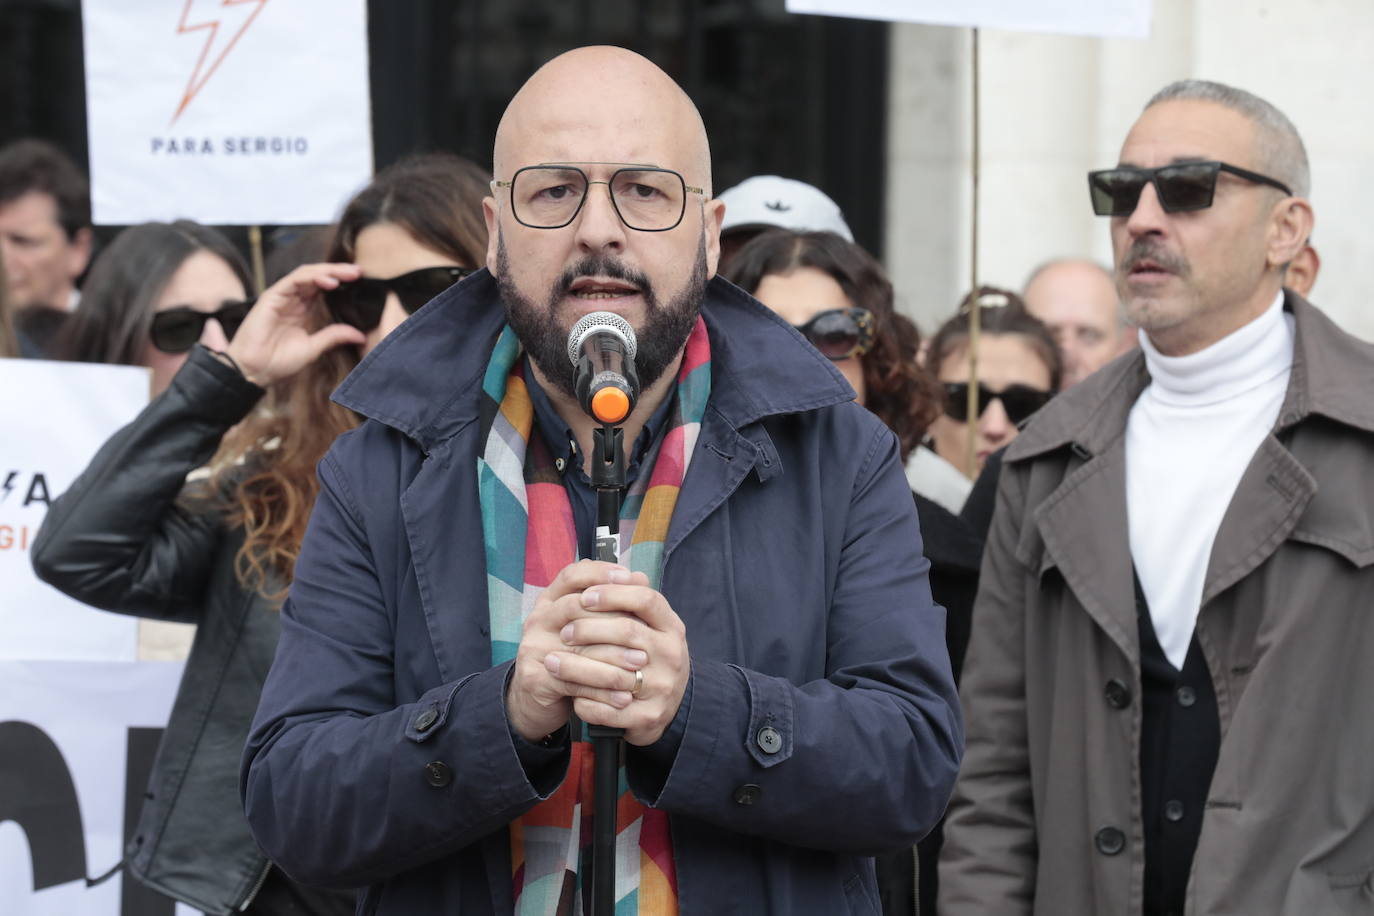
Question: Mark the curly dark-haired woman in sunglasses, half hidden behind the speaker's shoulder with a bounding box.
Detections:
[724,229,982,915]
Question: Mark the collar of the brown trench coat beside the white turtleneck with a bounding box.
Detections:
[1006,290,1374,463]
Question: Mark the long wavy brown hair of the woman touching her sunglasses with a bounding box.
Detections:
[209,154,491,602]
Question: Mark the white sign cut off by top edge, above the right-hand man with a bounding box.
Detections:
[787,0,1150,38]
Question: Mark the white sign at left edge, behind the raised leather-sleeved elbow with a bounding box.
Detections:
[0,360,148,661]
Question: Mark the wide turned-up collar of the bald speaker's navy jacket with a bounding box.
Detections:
[334,269,855,452]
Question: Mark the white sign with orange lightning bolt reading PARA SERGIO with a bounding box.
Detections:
[81,0,372,225]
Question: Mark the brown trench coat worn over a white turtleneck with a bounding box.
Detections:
[940,294,1374,916]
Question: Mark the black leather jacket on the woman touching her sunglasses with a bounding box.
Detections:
[32,346,289,915]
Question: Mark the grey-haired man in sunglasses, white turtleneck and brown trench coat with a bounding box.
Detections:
[940,81,1374,916]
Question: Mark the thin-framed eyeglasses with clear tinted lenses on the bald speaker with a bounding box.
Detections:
[492,162,706,232]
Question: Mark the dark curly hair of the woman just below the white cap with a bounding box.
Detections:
[721,229,941,460]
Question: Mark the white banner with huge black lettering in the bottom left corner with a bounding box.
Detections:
[0,661,195,916]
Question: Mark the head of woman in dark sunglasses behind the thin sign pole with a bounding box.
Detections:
[926,286,1061,479]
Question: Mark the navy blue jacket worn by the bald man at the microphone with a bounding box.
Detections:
[242,271,963,916]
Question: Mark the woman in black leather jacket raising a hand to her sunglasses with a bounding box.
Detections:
[33,157,489,915]
